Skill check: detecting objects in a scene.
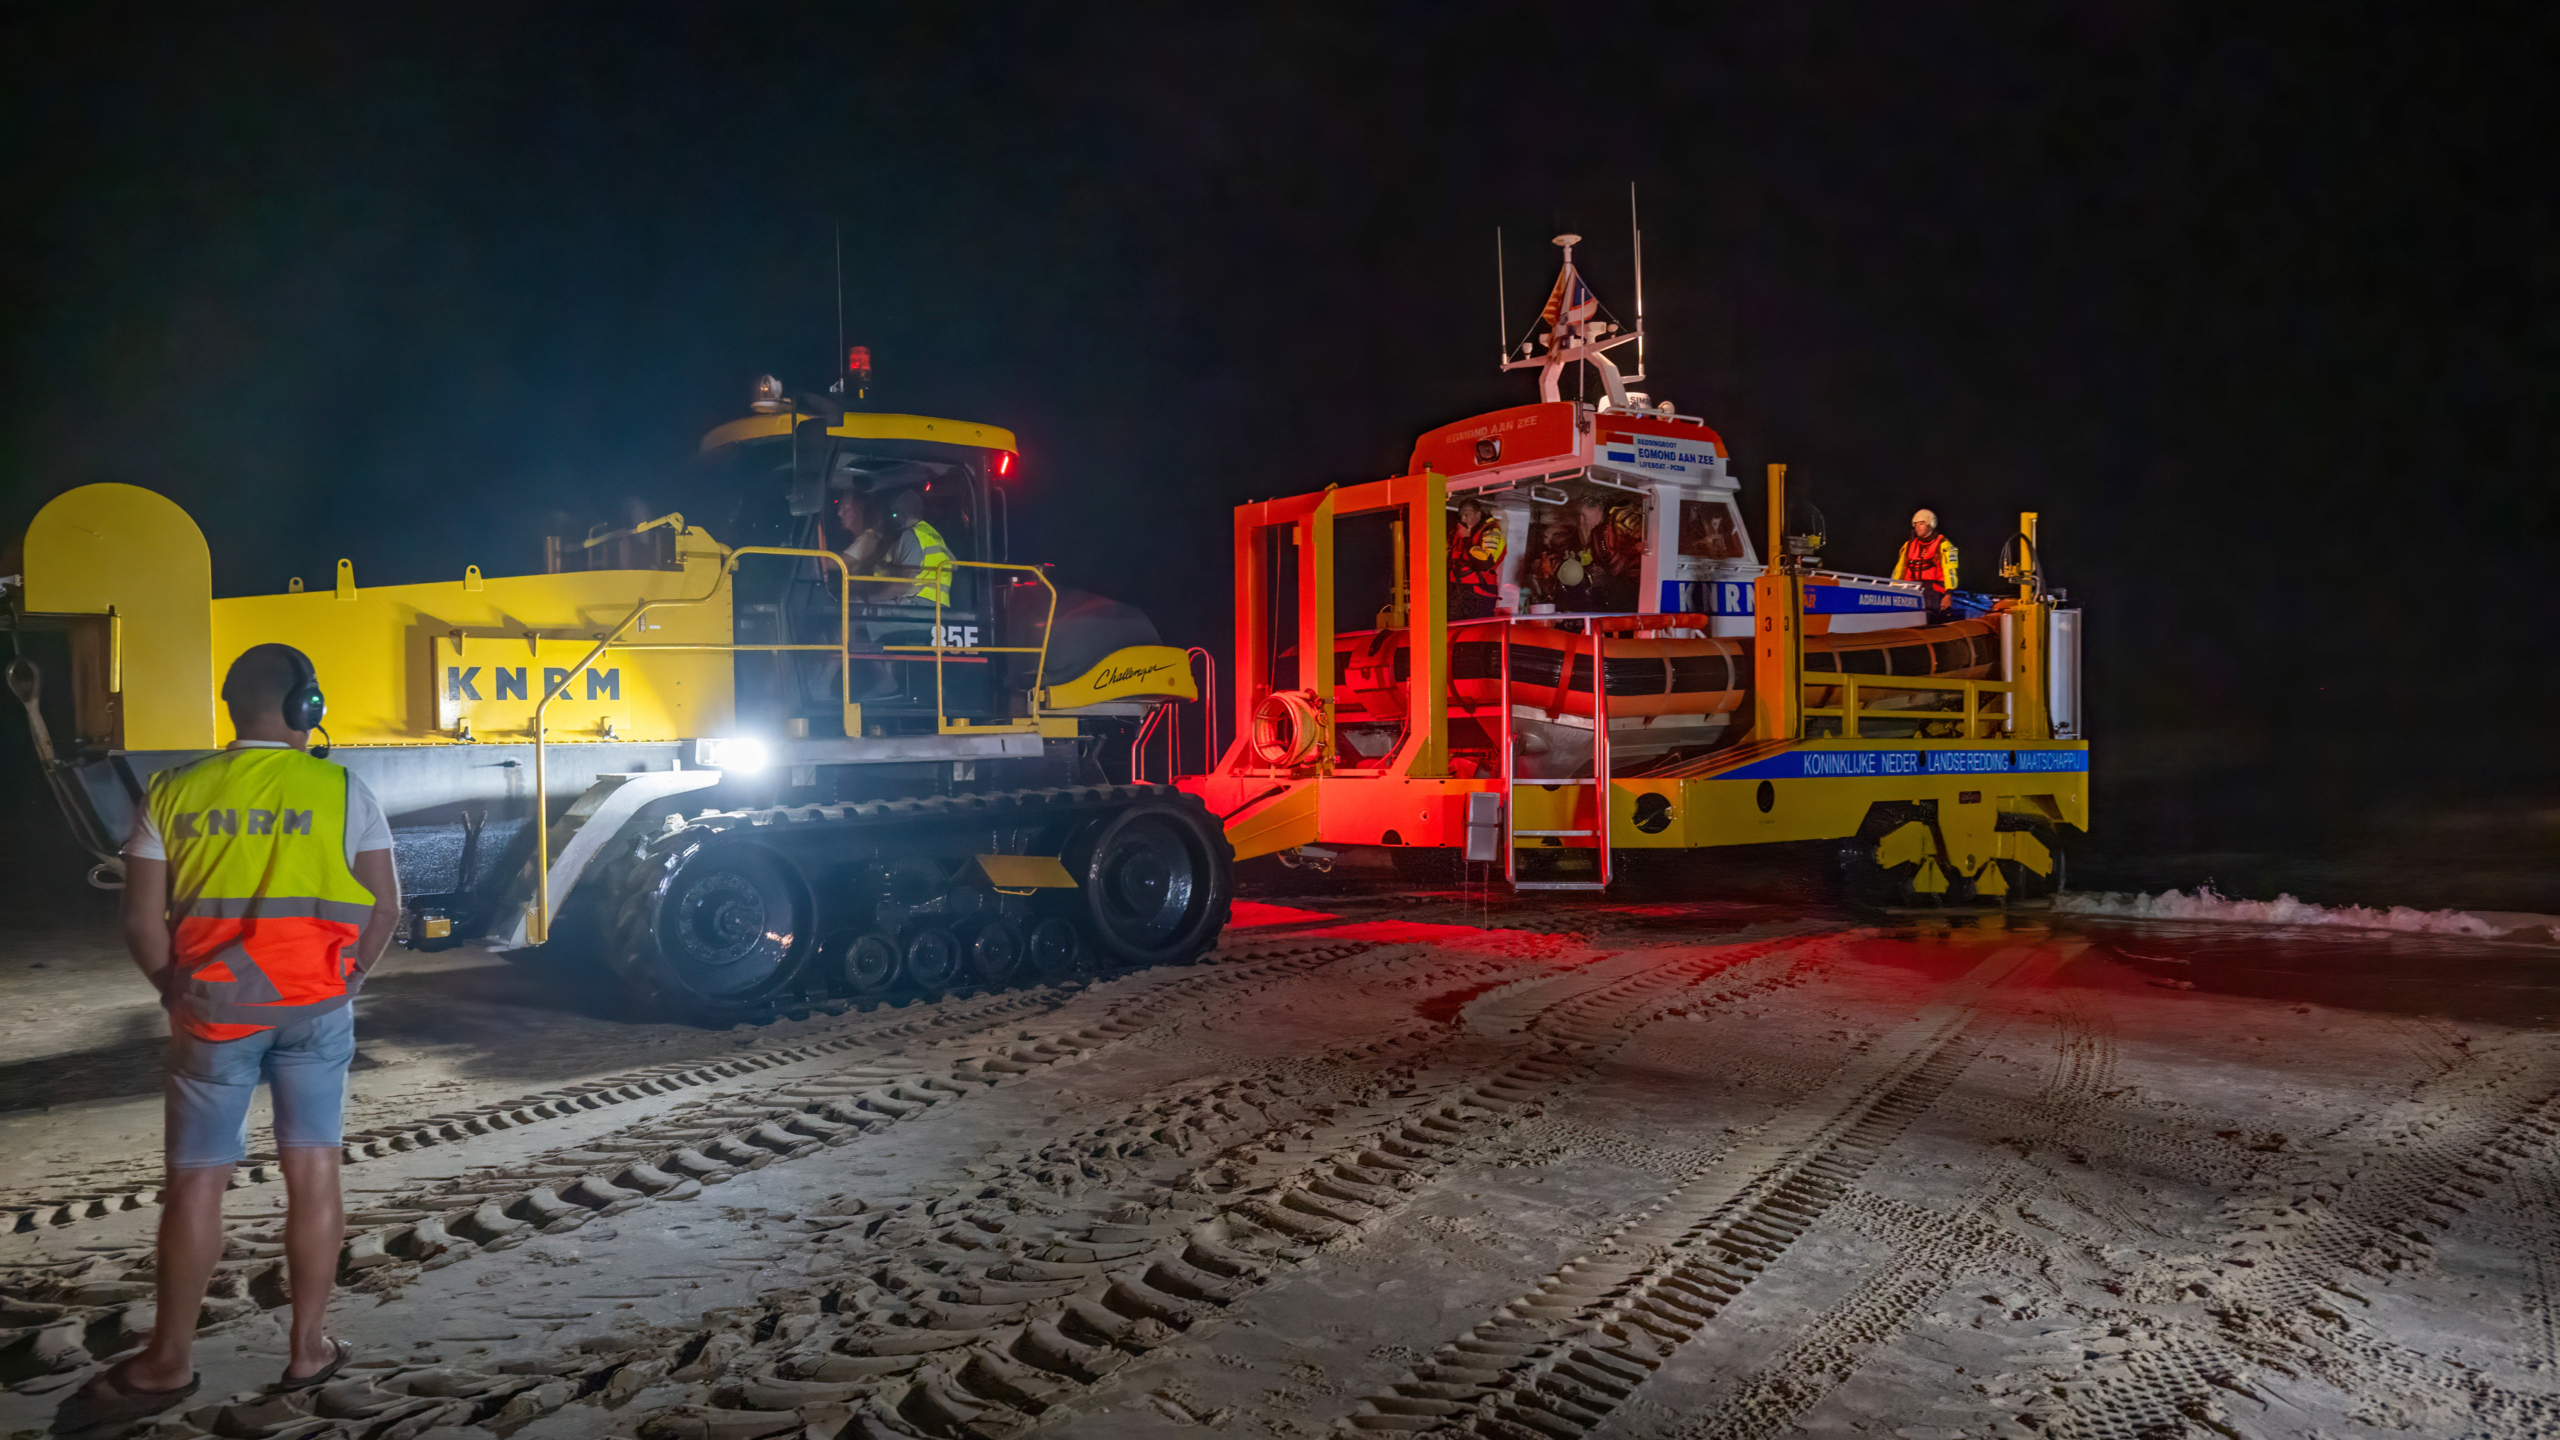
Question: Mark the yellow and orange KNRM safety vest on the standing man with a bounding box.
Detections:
[148,748,374,1040]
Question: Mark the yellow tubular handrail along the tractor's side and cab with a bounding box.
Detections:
[525,546,1057,945]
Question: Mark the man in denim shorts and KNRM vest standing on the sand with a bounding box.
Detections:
[77,646,399,1422]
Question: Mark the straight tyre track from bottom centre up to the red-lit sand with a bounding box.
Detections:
[1339,945,2056,1440]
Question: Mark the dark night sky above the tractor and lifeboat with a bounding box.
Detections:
[0,3,2560,896]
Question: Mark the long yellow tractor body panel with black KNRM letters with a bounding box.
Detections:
[212,530,735,746]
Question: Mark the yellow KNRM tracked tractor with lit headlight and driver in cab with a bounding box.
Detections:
[0,377,1231,1020]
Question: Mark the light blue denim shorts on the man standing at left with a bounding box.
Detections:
[161,1004,356,1168]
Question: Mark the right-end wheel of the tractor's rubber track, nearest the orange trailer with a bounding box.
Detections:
[1068,794,1236,966]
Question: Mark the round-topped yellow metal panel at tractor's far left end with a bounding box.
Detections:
[26,484,212,751]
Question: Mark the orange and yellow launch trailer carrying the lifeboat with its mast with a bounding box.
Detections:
[1180,236,2089,902]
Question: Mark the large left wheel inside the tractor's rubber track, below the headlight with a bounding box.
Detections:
[632,843,812,1015]
